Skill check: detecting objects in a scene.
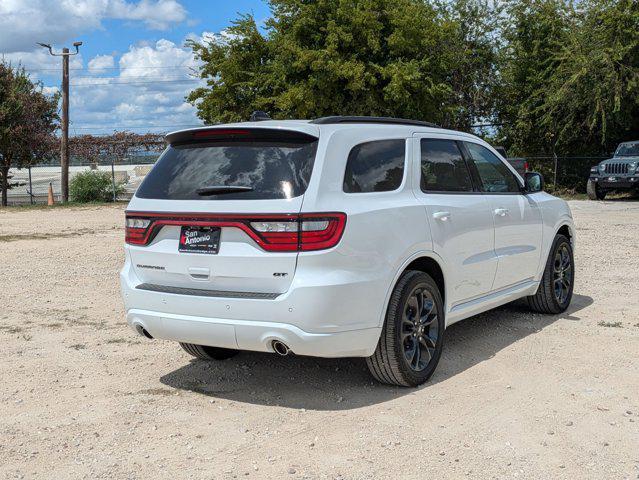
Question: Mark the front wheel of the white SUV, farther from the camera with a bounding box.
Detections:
[527,235,575,314]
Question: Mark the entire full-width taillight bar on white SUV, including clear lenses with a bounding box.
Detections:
[125,212,346,252]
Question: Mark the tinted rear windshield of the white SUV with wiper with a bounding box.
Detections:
[136,130,317,200]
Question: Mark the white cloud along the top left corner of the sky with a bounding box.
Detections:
[0,0,186,53]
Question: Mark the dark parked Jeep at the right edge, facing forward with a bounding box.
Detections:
[586,140,639,200]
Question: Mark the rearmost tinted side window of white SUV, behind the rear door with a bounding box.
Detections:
[344,139,406,193]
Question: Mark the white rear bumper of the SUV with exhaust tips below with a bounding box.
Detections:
[120,255,384,357]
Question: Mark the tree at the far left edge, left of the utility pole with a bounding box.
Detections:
[0,62,58,206]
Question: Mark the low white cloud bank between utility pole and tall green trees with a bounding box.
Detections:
[65,39,202,134]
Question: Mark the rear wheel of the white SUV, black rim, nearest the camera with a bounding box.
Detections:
[366,270,445,387]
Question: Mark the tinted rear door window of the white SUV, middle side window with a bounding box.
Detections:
[421,138,473,192]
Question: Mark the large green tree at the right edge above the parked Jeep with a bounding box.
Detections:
[497,0,639,155]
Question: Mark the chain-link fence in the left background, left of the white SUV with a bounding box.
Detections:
[7,154,159,205]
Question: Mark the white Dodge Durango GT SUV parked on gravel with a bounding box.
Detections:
[121,117,575,386]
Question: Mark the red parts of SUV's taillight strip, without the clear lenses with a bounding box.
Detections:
[125,211,346,252]
